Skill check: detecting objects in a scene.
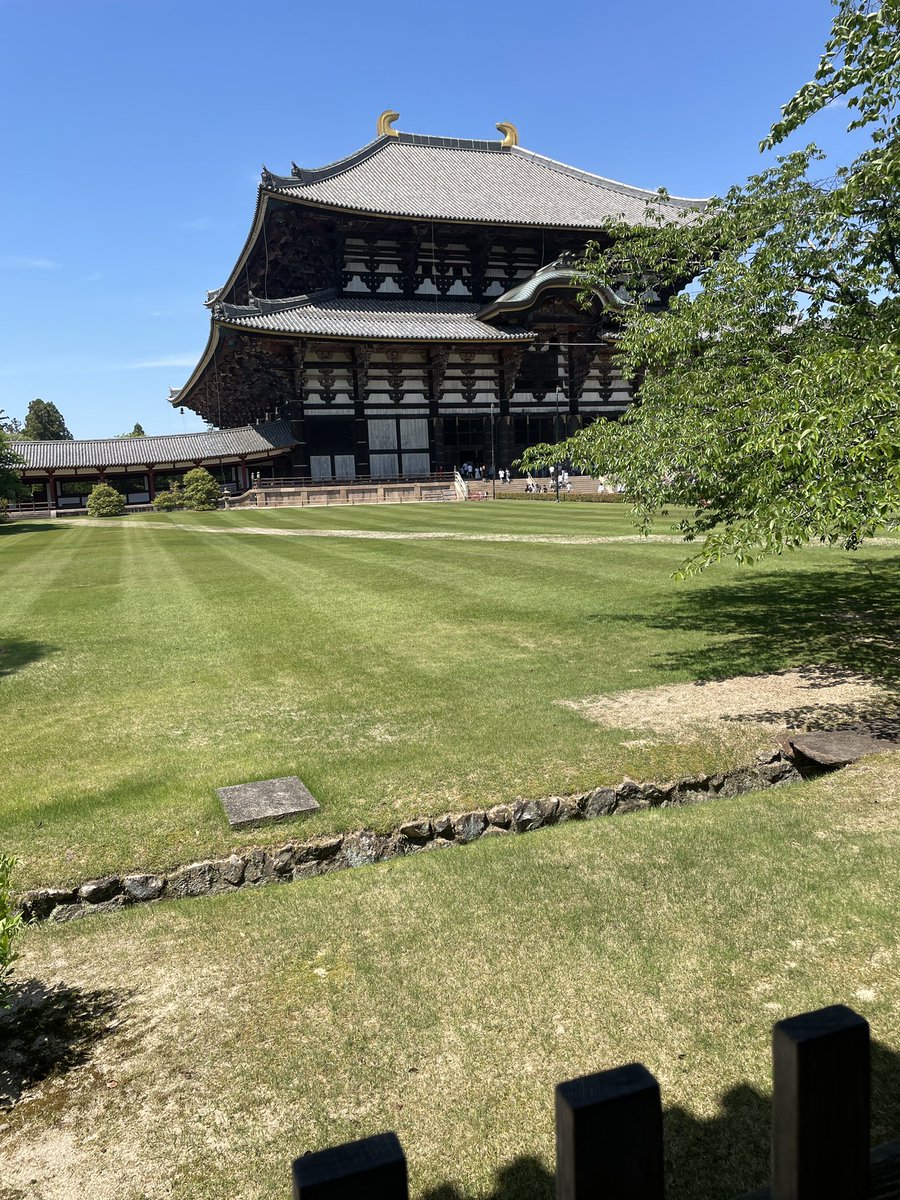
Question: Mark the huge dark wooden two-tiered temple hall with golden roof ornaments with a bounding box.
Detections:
[169,112,703,480]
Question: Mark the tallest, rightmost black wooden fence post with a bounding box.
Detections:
[772,1004,870,1200]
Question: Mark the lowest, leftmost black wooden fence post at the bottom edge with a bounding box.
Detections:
[292,1133,409,1200]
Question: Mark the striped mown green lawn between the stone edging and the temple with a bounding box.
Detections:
[0,504,900,887]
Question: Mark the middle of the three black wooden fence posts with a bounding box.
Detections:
[557,1063,664,1200]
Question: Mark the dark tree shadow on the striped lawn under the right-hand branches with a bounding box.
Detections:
[634,556,900,685]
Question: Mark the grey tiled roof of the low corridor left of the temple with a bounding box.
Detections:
[12,421,294,470]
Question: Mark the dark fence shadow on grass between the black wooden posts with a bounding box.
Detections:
[422,1042,900,1200]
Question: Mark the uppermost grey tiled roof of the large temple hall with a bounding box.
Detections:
[263,133,704,229]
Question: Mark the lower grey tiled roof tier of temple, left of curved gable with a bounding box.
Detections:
[212,290,532,342]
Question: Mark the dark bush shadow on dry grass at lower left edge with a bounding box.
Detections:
[0,979,127,1111]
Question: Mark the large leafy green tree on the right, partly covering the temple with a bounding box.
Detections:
[527,0,900,570]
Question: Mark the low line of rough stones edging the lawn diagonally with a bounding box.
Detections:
[22,750,804,922]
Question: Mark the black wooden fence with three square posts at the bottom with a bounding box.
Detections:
[293,1004,894,1200]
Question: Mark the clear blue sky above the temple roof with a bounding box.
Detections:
[0,0,847,437]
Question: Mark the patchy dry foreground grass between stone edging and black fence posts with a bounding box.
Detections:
[0,753,900,1200]
